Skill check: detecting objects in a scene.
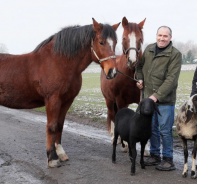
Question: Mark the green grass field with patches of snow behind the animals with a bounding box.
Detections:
[36,66,194,126]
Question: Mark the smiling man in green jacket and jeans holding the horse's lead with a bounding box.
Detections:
[137,26,182,171]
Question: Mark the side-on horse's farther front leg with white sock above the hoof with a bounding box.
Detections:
[55,99,74,162]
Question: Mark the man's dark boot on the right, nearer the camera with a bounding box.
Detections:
[155,157,176,171]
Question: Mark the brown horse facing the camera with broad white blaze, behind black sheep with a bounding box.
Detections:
[101,17,146,136]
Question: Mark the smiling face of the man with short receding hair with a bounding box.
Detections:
[156,27,172,48]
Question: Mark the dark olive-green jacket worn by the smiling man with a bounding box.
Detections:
[137,43,182,105]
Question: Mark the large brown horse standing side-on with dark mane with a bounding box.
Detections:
[0,19,120,167]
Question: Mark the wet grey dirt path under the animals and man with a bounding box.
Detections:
[0,107,196,184]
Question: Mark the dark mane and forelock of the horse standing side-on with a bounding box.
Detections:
[33,24,117,58]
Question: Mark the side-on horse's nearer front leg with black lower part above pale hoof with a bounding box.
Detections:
[45,96,61,167]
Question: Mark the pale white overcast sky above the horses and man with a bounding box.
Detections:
[0,0,197,54]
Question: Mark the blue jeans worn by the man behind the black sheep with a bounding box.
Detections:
[150,105,175,158]
